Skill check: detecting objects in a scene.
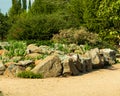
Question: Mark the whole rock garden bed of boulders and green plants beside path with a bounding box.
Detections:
[0,41,120,78]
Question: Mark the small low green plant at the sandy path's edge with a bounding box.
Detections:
[17,71,43,79]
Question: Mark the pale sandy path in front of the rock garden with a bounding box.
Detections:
[0,64,120,96]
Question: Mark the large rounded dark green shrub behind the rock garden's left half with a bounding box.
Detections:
[8,14,65,40]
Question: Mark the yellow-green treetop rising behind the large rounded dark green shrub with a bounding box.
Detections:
[31,0,66,15]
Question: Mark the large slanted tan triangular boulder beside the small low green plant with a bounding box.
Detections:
[32,54,62,77]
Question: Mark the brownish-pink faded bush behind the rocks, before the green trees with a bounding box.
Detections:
[52,28,98,44]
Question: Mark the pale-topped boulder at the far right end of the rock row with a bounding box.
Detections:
[100,49,116,65]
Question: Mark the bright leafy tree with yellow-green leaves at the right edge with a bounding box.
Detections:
[97,0,120,44]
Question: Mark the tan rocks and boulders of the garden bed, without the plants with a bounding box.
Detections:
[0,44,116,78]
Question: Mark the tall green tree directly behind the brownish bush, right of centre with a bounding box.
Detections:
[67,0,101,31]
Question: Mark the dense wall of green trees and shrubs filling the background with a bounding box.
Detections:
[0,0,120,44]
